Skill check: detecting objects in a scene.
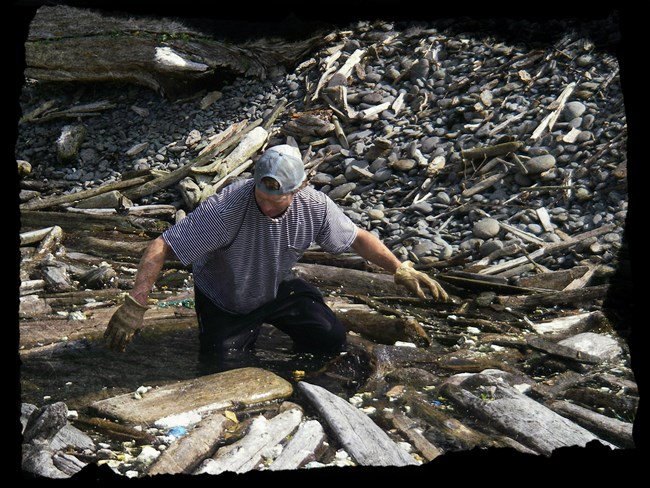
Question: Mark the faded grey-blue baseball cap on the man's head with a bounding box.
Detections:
[255,144,306,195]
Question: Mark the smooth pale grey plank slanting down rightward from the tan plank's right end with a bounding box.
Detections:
[298,381,417,466]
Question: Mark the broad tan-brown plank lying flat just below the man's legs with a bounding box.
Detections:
[90,368,293,423]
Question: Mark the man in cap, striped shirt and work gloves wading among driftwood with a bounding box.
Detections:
[104,144,448,364]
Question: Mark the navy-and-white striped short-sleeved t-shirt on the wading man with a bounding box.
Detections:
[162,180,357,314]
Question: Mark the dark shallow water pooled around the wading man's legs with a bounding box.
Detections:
[20,326,365,411]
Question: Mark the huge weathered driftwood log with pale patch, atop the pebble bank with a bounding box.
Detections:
[25,6,325,96]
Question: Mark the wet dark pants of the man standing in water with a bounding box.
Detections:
[194,278,346,366]
